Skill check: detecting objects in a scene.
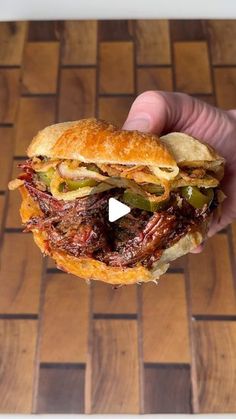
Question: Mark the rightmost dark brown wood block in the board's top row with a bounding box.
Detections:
[170,19,207,42]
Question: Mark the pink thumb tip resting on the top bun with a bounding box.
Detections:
[123,91,170,135]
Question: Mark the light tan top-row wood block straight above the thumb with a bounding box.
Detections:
[136,20,171,64]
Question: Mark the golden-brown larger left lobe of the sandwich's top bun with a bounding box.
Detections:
[27,118,176,168]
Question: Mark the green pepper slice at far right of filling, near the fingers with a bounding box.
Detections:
[181,186,214,208]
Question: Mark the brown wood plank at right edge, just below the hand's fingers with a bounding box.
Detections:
[188,234,236,315]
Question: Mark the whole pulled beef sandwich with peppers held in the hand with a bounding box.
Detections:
[9,118,225,284]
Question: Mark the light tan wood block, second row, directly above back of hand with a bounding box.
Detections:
[174,42,212,93]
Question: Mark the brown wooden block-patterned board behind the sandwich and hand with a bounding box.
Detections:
[0,20,236,413]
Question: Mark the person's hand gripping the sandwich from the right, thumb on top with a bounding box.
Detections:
[123,91,236,251]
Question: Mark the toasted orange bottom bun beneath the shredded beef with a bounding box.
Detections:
[20,186,207,285]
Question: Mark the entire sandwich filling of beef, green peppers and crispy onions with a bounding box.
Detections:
[12,157,219,268]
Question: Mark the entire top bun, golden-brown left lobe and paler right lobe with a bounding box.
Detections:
[27,118,224,172]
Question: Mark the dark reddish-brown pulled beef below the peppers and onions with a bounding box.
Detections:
[20,164,216,268]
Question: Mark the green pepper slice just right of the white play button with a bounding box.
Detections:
[123,189,166,212]
